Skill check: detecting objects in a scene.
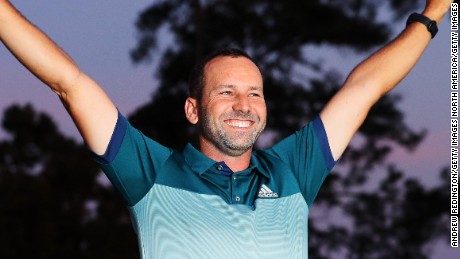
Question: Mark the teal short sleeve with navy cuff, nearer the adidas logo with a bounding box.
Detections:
[268,116,335,207]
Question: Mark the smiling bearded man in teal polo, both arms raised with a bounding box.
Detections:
[0,0,452,258]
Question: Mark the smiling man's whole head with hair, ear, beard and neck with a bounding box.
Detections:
[185,49,267,169]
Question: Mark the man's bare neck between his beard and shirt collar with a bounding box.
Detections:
[200,139,252,172]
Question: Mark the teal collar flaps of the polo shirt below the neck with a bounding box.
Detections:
[183,143,270,178]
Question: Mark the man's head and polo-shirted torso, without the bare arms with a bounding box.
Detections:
[96,49,334,258]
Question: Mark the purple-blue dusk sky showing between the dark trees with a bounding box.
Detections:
[0,0,460,258]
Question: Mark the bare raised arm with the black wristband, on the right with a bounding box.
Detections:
[320,0,453,159]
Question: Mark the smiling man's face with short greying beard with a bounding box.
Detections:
[198,57,267,156]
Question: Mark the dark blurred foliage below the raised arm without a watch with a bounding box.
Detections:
[0,105,139,259]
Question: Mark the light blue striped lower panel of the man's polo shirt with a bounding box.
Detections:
[131,184,308,259]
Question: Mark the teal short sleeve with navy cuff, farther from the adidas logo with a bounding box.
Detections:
[93,113,171,206]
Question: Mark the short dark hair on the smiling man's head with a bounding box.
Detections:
[188,48,260,100]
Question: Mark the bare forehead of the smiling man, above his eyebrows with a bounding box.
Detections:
[204,57,263,90]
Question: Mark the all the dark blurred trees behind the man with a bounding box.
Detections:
[0,0,449,258]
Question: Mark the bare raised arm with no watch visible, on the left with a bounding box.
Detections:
[0,0,117,154]
